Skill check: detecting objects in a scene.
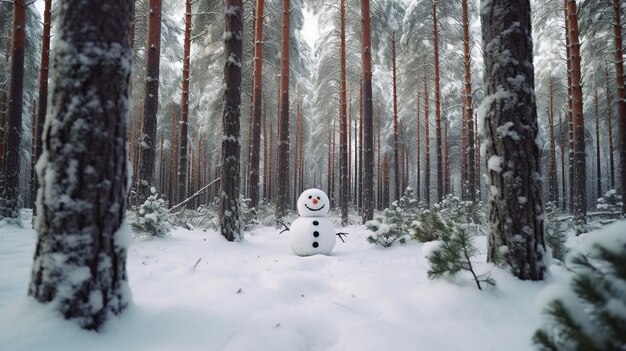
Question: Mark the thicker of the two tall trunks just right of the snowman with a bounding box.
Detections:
[361,0,374,223]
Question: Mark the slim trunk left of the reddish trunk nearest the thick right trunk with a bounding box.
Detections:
[432,0,444,202]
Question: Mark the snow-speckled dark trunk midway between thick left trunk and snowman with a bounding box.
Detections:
[220,0,243,241]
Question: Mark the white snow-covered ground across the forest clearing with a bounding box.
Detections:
[0,212,616,351]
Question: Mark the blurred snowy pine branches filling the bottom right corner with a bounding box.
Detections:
[533,227,626,351]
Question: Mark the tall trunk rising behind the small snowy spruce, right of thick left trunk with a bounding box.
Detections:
[137,0,161,204]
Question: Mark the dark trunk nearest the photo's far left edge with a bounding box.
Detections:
[0,0,26,218]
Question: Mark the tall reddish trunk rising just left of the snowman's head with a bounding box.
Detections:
[276,0,291,218]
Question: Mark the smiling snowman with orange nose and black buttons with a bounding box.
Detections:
[288,189,345,256]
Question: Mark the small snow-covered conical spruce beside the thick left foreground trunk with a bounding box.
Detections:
[130,187,172,238]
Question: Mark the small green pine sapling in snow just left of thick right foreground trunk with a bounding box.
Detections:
[427,228,495,290]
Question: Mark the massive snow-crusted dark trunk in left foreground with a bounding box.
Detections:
[28,0,132,330]
